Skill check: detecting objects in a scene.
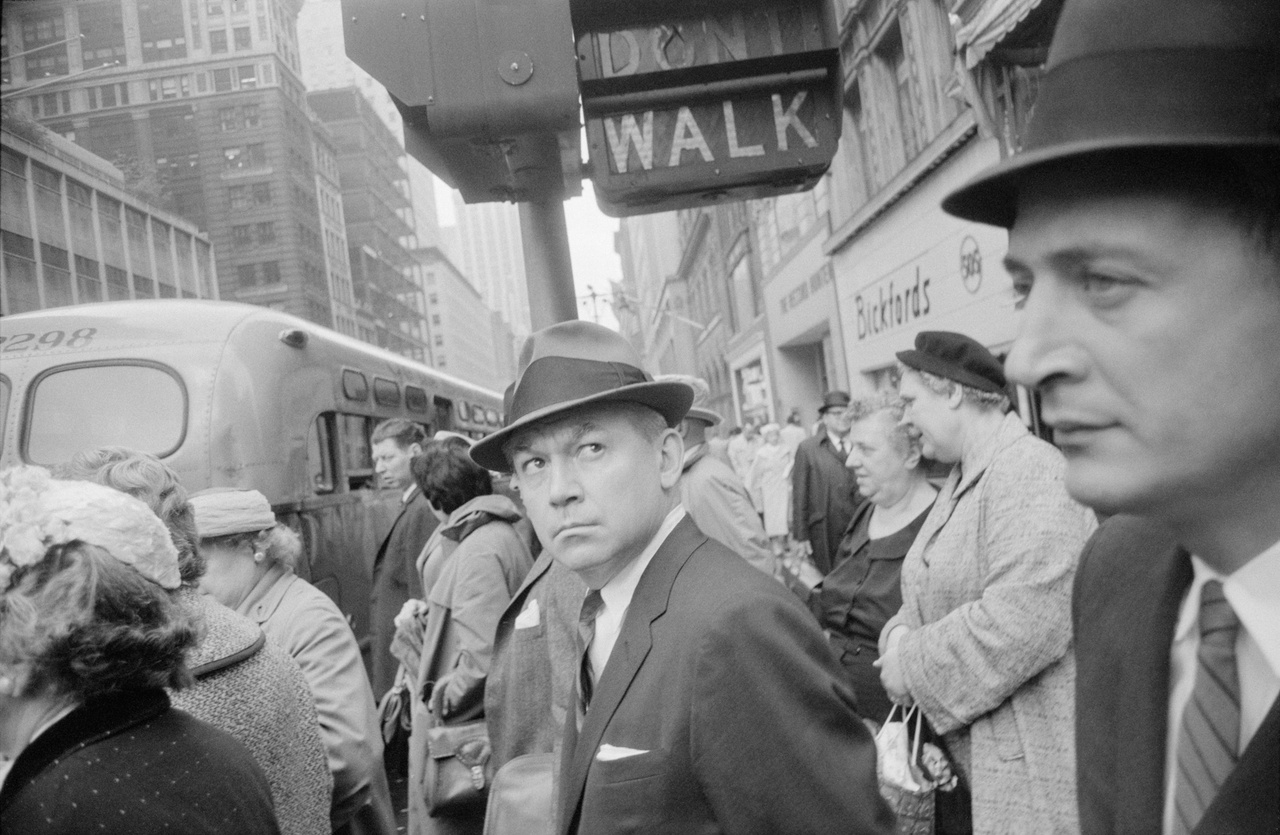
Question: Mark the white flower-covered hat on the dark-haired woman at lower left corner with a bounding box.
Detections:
[0,466,182,590]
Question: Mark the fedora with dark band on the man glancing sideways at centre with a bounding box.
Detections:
[471,320,694,473]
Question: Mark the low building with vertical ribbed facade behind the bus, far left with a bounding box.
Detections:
[0,114,218,315]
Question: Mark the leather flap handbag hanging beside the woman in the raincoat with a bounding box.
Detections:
[422,720,493,817]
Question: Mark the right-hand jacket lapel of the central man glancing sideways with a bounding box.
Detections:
[559,515,707,832]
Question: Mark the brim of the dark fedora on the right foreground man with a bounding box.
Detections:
[942,137,1277,229]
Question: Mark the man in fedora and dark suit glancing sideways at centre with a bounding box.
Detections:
[471,321,892,835]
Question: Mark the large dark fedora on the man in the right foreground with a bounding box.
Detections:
[942,0,1280,228]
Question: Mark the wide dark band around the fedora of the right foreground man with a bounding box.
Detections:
[1023,47,1280,152]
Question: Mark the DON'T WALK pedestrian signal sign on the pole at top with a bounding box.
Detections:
[577,1,841,215]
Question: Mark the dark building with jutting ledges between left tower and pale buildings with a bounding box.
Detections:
[307,87,430,362]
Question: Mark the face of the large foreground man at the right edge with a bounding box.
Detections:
[1006,173,1280,519]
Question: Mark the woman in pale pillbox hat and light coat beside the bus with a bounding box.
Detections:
[191,489,394,832]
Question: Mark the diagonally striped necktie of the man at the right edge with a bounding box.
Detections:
[1174,580,1240,835]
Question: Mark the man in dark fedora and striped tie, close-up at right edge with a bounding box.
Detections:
[943,0,1280,834]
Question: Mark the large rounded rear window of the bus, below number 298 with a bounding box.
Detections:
[23,362,187,465]
